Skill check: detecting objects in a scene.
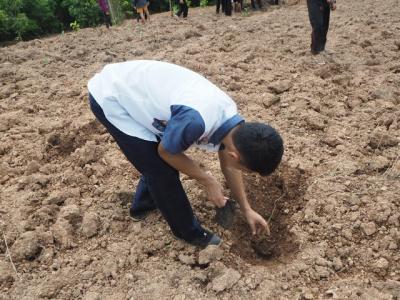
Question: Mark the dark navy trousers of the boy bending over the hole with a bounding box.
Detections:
[89,95,204,241]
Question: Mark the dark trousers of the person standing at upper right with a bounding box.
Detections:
[307,0,331,54]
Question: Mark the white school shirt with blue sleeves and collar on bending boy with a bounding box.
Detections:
[88,60,244,153]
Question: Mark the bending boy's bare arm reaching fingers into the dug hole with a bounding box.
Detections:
[218,150,270,235]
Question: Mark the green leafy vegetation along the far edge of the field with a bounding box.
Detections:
[0,0,216,42]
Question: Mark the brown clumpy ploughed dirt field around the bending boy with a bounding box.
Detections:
[0,0,400,300]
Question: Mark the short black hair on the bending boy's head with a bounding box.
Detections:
[232,122,283,176]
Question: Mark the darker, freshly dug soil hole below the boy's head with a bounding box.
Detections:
[231,164,307,264]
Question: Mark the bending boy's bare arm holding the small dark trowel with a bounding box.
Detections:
[158,143,226,207]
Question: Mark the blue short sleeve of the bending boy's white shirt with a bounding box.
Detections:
[161,105,205,154]
